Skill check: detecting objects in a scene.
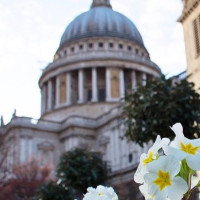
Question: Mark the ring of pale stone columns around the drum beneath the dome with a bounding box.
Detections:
[41,67,147,114]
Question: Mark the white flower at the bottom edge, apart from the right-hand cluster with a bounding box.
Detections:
[83,185,118,200]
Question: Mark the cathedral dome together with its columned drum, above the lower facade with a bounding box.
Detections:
[39,0,160,121]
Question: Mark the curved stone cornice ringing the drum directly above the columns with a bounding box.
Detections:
[39,52,161,88]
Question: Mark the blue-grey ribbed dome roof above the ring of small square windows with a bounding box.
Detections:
[60,5,144,47]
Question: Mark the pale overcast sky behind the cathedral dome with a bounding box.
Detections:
[0,0,186,122]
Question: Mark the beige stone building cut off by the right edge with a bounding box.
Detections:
[179,0,200,89]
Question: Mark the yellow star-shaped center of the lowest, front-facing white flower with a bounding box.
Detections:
[153,170,171,191]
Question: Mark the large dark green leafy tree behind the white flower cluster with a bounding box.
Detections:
[124,76,200,145]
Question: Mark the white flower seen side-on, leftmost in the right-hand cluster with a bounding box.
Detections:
[134,135,169,184]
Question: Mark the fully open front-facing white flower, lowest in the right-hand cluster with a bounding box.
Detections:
[144,156,188,200]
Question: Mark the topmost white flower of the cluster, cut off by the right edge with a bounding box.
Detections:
[163,123,200,170]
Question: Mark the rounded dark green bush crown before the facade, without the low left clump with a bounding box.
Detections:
[57,149,107,194]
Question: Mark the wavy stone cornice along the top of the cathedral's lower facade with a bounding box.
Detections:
[3,105,122,135]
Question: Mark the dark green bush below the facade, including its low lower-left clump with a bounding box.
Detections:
[35,149,107,200]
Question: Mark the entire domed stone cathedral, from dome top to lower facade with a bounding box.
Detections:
[0,0,161,200]
